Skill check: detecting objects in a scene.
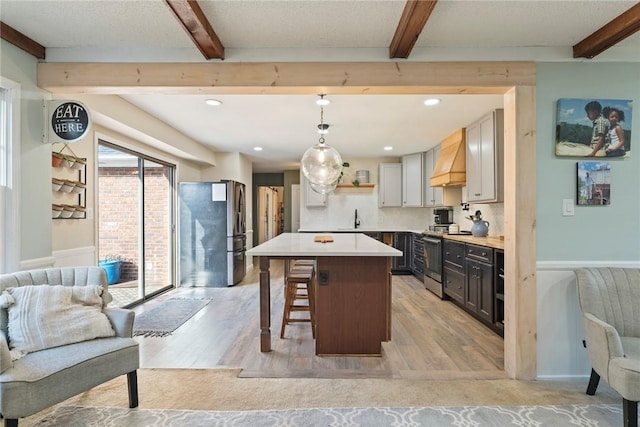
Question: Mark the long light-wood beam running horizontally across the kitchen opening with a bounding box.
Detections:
[37,61,536,95]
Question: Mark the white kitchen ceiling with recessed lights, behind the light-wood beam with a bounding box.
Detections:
[123,95,502,172]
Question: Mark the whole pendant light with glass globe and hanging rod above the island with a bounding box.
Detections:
[300,95,342,194]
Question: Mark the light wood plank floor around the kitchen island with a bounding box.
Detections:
[135,261,507,380]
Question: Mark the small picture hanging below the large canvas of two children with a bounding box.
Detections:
[578,162,611,206]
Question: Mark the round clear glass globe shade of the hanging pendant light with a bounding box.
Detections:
[300,143,342,188]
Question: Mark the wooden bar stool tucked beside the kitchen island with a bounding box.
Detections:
[280,262,316,338]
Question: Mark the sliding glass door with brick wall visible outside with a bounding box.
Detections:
[97,140,176,307]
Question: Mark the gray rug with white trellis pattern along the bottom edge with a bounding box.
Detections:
[34,404,622,427]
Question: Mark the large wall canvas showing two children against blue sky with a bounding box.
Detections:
[556,98,633,158]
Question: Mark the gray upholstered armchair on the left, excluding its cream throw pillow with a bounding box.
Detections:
[0,267,140,427]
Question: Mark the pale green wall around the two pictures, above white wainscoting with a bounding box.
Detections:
[536,63,640,262]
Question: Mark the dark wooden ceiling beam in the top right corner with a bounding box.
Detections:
[573,3,640,58]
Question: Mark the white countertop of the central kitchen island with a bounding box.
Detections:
[247,233,402,256]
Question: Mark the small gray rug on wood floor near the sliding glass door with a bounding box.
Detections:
[133,298,211,337]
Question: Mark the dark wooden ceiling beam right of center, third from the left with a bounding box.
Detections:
[389,0,438,58]
